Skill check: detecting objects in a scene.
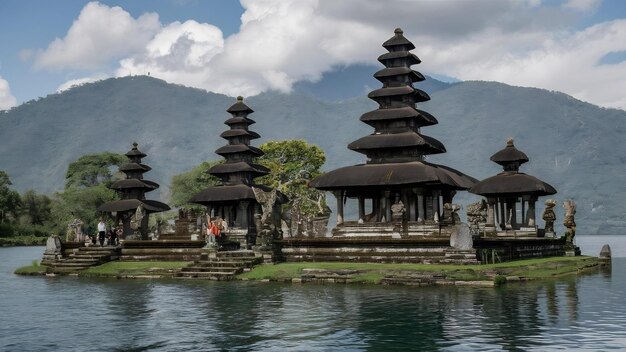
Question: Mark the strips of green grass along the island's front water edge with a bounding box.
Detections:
[15,256,599,286]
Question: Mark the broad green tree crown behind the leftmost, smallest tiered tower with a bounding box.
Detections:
[65,152,128,189]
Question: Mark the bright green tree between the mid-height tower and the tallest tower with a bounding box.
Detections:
[258,139,330,217]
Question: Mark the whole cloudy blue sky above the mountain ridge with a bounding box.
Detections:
[0,0,626,109]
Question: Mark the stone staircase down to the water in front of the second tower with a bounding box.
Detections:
[177,250,263,280]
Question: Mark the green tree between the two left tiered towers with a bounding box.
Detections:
[170,161,223,207]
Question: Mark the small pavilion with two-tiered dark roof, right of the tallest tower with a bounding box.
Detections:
[469,139,556,236]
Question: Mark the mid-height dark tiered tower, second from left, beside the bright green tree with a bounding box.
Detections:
[190,97,282,247]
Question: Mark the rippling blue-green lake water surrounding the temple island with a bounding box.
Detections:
[0,236,626,351]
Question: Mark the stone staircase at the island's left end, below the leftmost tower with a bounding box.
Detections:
[42,246,120,274]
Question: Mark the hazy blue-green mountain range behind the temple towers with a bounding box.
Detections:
[0,73,626,234]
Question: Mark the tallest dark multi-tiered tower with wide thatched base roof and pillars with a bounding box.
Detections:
[311,28,476,236]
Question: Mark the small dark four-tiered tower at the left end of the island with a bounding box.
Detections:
[98,143,170,240]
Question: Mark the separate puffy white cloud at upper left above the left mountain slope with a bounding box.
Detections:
[35,2,160,69]
